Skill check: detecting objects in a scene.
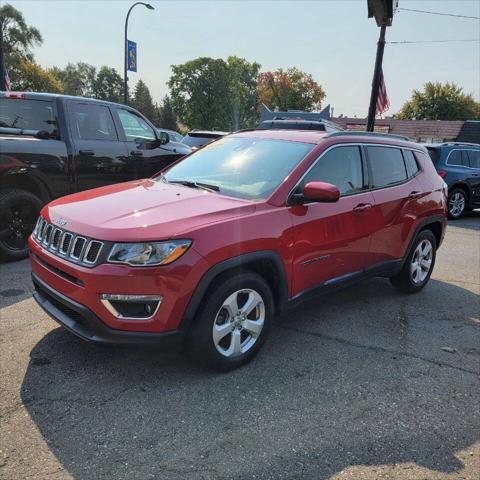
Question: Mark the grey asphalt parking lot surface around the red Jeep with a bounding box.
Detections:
[0,212,480,480]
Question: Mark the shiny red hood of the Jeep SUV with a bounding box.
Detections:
[42,179,255,242]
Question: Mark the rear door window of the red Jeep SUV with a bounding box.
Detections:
[367,147,407,188]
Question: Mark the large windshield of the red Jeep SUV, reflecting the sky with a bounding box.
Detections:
[161,137,314,200]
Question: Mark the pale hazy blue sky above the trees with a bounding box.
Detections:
[7,0,480,117]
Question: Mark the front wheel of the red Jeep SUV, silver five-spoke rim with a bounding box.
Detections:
[187,273,274,372]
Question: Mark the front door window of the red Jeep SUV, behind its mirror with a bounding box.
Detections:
[302,147,364,195]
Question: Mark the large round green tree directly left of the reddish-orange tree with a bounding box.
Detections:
[168,56,260,130]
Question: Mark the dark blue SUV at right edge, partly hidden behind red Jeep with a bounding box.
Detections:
[426,143,480,220]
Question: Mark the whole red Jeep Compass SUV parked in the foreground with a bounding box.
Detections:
[29,130,447,370]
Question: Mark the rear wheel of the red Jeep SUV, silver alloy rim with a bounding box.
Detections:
[390,230,437,293]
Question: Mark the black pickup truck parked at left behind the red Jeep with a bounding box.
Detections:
[0,92,191,260]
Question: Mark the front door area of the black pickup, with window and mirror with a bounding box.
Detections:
[115,107,184,178]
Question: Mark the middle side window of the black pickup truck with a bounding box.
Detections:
[70,103,118,140]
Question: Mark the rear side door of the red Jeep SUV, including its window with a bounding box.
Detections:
[365,145,423,263]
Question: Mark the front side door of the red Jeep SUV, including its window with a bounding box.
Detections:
[290,145,379,296]
